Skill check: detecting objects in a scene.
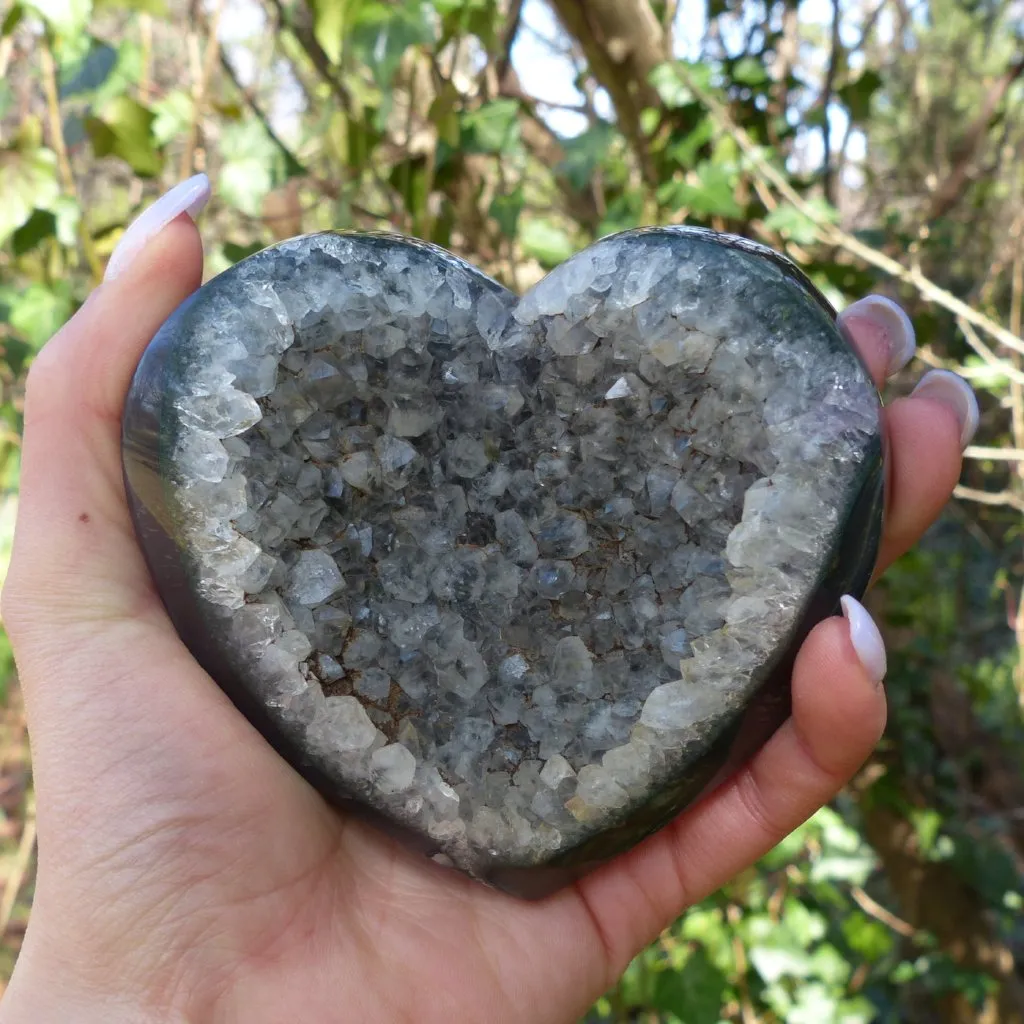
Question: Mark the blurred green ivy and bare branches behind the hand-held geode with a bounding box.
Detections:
[0,0,1024,1024]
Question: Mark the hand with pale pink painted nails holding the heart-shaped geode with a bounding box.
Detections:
[0,184,977,1024]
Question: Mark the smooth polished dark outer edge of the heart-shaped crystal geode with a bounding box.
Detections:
[122,228,884,899]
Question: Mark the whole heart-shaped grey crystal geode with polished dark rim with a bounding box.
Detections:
[124,228,882,895]
